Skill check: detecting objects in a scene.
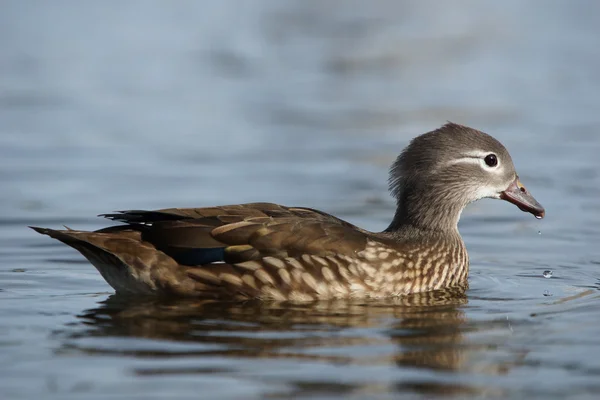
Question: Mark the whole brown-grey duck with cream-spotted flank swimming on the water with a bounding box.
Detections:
[31,122,545,301]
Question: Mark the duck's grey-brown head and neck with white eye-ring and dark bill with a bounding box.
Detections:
[390,123,544,229]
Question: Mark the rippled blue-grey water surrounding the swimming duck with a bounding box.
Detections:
[0,0,600,399]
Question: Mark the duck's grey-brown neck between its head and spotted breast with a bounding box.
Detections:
[385,188,466,235]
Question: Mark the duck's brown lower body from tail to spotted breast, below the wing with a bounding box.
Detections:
[35,222,468,301]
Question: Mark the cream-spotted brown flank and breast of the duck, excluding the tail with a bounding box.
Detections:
[183,239,468,301]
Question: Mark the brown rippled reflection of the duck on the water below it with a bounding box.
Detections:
[59,289,510,394]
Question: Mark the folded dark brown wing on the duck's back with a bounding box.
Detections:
[99,203,368,266]
